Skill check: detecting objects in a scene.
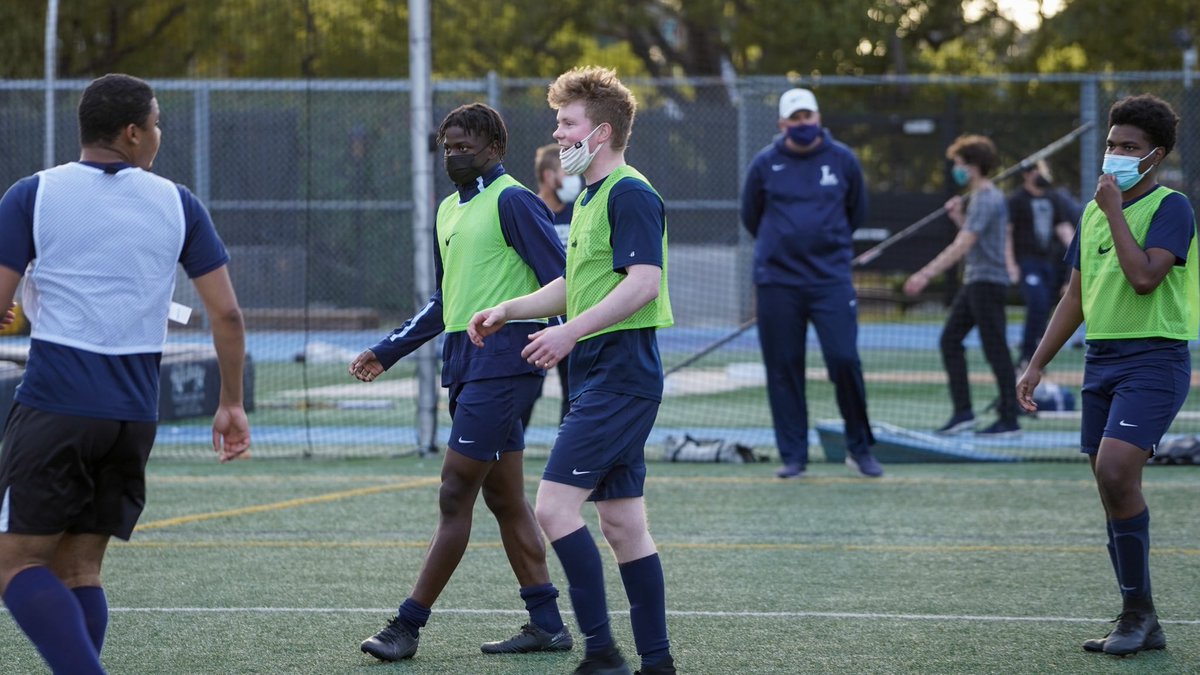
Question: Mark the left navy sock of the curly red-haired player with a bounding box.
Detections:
[551,525,612,656]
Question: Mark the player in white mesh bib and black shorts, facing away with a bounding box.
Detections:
[0,74,250,675]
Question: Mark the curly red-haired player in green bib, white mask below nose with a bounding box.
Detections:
[467,66,676,675]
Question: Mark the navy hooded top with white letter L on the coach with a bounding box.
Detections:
[742,130,866,287]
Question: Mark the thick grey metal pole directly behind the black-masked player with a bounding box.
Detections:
[408,0,439,455]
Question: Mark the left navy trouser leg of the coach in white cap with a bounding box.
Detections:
[756,286,809,471]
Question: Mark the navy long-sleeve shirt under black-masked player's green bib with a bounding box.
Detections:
[371,165,566,387]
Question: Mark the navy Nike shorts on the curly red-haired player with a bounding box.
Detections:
[541,390,659,501]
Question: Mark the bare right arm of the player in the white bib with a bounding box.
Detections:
[192,265,250,461]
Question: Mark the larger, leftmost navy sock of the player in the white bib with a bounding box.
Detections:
[4,567,104,675]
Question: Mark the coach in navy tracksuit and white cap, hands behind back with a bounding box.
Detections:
[742,89,883,478]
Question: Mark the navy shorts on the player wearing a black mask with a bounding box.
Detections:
[449,374,545,461]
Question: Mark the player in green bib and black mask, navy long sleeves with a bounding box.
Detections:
[349,103,572,661]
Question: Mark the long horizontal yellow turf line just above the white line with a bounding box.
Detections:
[120,539,1200,557]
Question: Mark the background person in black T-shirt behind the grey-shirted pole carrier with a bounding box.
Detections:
[1008,160,1075,370]
